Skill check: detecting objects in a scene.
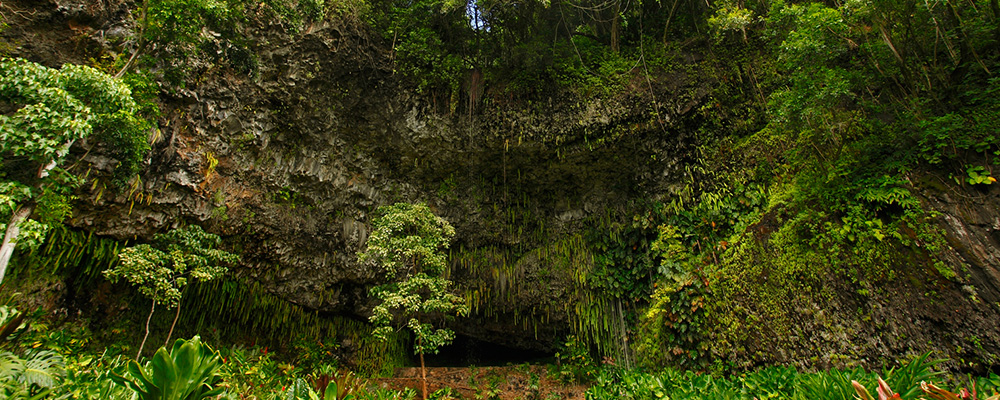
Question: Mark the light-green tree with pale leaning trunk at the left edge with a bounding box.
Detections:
[0,59,149,282]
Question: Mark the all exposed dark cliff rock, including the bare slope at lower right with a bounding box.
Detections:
[7,0,1000,367]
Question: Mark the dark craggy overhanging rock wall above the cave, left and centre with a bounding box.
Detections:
[4,0,707,348]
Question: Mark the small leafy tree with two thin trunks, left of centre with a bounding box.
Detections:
[104,225,239,360]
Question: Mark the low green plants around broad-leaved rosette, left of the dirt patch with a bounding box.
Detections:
[0,306,414,400]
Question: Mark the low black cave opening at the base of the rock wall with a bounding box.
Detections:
[418,335,555,367]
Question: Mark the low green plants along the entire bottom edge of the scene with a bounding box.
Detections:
[0,306,1000,400]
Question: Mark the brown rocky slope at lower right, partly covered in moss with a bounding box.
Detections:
[712,173,1000,374]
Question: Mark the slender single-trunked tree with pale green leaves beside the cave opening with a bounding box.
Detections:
[359,203,469,399]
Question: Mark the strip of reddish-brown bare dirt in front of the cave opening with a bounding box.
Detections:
[377,365,587,400]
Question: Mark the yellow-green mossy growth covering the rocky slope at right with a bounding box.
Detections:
[707,191,955,365]
